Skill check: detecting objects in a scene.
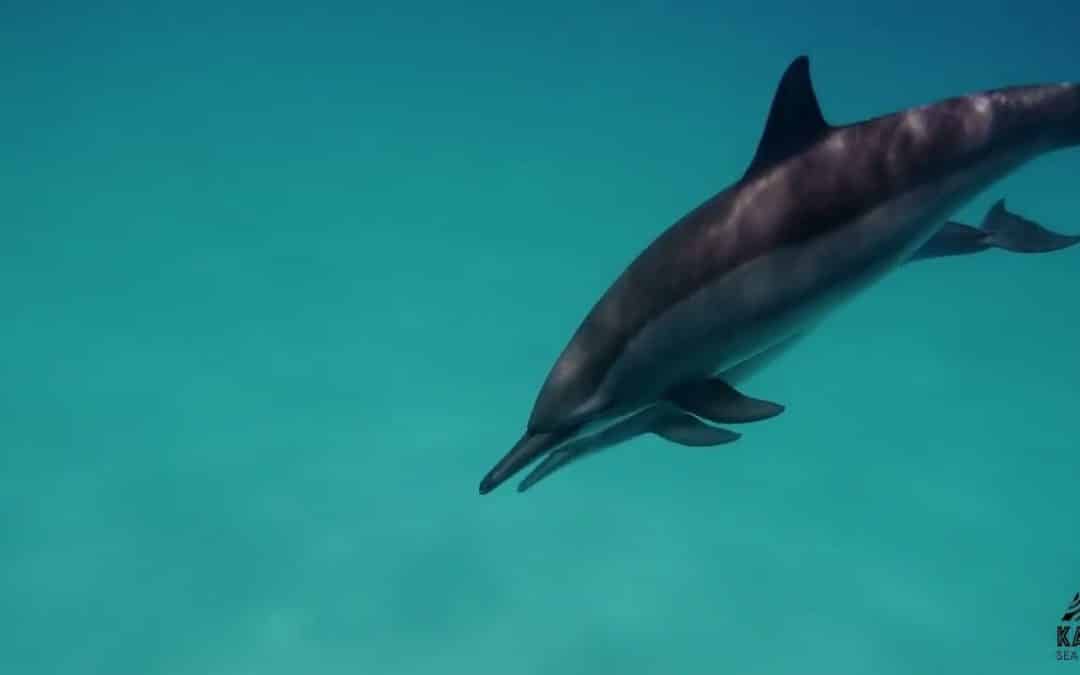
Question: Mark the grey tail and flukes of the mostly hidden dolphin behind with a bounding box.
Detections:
[910,200,1080,260]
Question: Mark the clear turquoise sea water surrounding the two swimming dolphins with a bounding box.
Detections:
[0,0,1080,675]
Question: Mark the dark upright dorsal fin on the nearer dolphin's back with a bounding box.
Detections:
[746,56,829,175]
